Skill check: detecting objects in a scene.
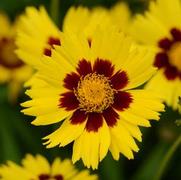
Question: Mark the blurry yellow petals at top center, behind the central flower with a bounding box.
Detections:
[63,2,131,40]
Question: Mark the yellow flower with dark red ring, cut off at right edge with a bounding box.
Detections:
[131,0,181,109]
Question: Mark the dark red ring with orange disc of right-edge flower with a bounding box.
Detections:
[154,28,181,80]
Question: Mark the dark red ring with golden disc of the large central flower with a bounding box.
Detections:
[59,58,133,132]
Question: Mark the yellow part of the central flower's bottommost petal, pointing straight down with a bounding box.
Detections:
[72,121,110,169]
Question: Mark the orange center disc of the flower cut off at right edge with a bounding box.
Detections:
[168,42,181,71]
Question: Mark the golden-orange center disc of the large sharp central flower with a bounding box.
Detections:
[74,73,115,113]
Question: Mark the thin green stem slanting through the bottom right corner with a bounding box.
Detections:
[154,135,181,180]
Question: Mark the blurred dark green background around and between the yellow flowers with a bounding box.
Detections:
[0,0,181,180]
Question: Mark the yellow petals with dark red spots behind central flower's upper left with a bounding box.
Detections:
[16,7,61,66]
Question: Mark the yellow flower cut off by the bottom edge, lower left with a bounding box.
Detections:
[0,154,98,180]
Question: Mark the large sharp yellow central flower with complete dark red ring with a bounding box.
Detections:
[22,28,164,169]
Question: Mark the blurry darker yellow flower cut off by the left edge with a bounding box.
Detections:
[0,13,32,101]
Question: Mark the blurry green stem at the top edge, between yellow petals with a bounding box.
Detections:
[50,0,60,24]
